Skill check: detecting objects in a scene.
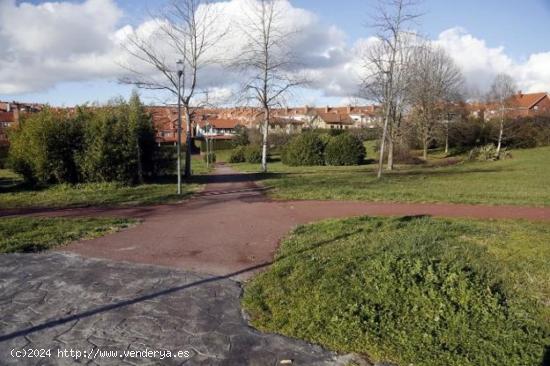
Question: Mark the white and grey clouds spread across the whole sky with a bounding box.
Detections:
[0,0,550,99]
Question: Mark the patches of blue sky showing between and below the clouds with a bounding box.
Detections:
[0,0,550,105]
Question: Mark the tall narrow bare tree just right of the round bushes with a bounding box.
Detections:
[363,0,420,178]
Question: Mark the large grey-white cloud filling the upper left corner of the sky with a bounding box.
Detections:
[0,0,122,94]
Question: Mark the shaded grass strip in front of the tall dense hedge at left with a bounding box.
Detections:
[0,157,207,209]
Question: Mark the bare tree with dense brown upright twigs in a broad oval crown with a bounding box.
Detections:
[409,43,464,160]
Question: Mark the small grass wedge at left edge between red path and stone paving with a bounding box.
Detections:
[0,217,136,253]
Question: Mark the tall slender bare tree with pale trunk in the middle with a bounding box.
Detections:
[235,0,306,172]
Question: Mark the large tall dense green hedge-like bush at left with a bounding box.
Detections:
[9,93,157,183]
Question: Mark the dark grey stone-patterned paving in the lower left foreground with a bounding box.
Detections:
[0,253,362,366]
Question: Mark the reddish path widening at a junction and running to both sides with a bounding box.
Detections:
[0,166,550,278]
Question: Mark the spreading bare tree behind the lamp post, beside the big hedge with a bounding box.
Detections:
[121,0,227,181]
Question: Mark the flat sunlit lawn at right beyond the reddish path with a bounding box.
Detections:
[233,147,550,206]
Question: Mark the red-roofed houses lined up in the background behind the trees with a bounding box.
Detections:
[0,91,550,145]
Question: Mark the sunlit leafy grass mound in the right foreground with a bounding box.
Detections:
[246,217,550,366]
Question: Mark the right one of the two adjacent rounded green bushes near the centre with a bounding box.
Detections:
[325,133,366,165]
